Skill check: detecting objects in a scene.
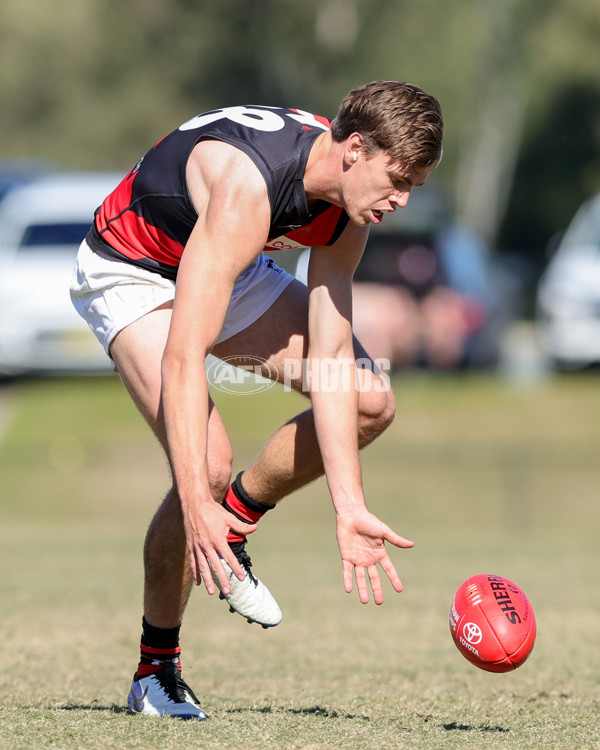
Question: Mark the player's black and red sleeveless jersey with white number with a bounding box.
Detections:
[87,106,348,279]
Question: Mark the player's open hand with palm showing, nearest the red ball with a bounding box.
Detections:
[336,509,414,604]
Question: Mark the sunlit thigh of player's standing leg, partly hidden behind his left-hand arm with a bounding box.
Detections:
[110,302,231,476]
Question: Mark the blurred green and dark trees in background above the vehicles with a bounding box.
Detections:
[0,0,600,262]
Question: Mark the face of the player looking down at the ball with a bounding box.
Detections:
[344,151,429,226]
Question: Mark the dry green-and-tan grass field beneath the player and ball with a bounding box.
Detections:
[0,376,600,750]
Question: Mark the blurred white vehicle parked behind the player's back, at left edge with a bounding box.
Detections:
[0,173,120,377]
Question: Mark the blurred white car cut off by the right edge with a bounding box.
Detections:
[537,194,600,370]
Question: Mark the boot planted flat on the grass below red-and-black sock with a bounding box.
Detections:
[127,664,207,721]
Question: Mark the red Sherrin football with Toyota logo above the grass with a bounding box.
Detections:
[450,575,536,672]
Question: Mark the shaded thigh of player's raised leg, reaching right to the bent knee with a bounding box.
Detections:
[213,281,387,406]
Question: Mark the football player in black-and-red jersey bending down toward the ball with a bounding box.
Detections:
[71,81,443,719]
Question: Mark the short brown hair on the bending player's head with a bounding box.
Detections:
[331,81,444,169]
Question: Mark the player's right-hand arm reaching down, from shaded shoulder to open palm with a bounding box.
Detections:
[307,224,412,604]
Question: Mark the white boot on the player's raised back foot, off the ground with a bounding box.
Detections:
[213,542,283,628]
